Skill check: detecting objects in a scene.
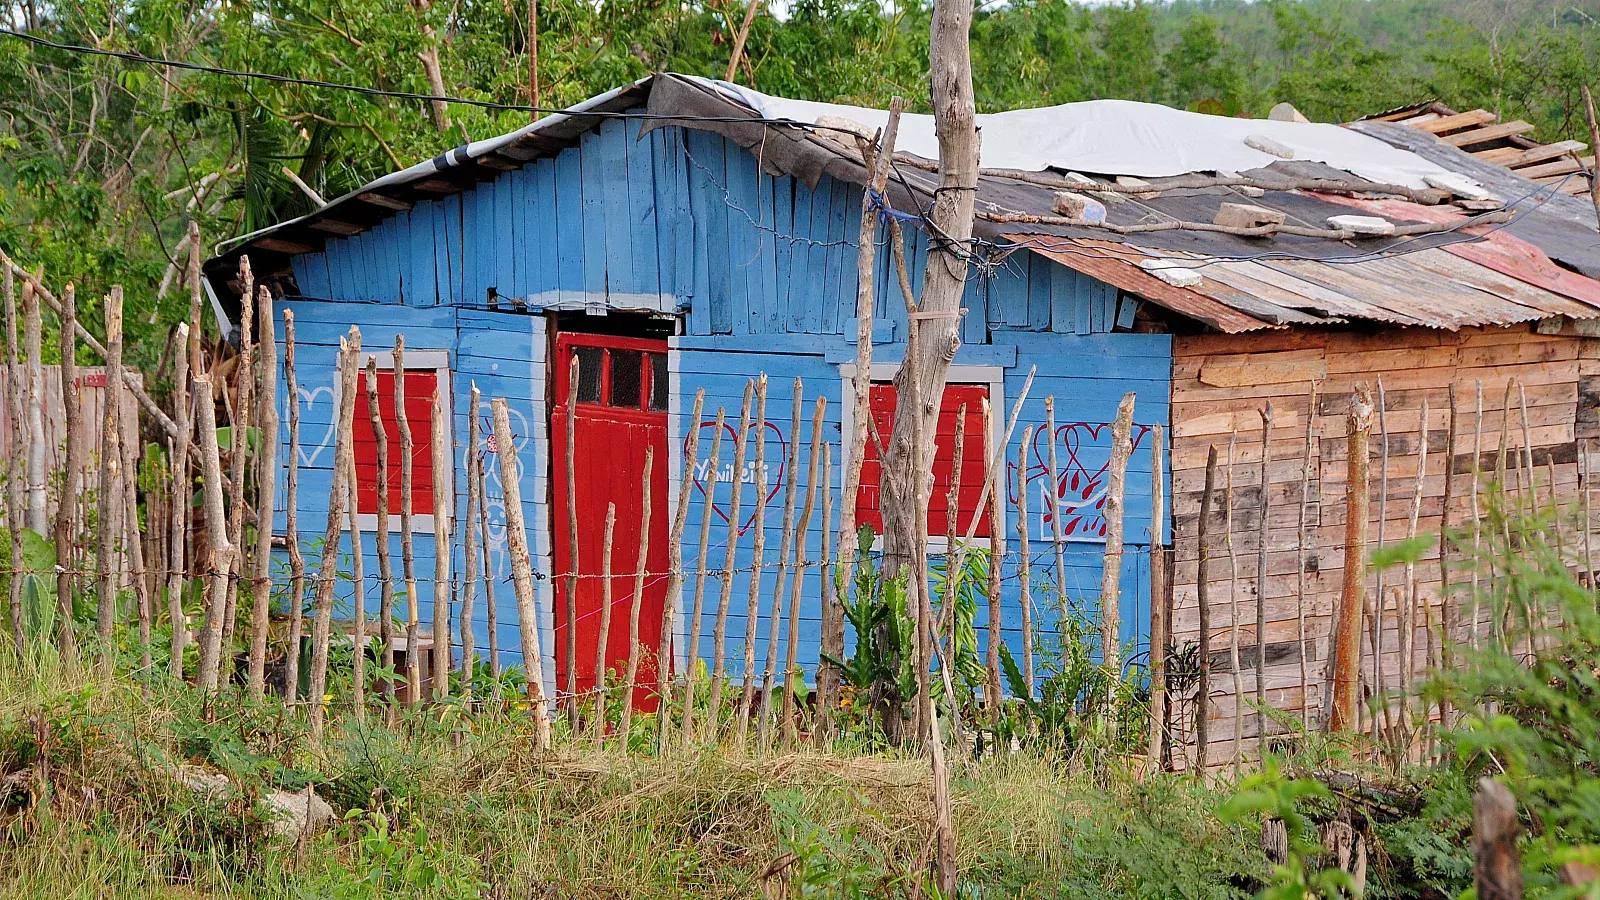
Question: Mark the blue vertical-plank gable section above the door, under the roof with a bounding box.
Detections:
[284,120,1113,344]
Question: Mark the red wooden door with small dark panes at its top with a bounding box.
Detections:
[550,333,670,709]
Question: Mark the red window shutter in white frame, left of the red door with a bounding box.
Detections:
[350,368,450,515]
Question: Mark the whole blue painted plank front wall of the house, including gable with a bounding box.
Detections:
[280,112,1171,685]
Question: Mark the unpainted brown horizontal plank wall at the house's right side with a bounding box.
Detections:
[1171,325,1600,762]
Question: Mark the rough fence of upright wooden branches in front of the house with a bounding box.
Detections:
[0,254,1595,769]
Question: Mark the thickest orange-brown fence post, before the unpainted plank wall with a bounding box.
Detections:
[1328,386,1373,732]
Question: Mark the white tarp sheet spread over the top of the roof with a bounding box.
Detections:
[702,80,1448,189]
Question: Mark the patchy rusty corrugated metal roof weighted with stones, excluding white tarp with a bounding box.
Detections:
[206,75,1600,333]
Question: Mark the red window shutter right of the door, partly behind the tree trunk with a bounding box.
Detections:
[856,384,989,538]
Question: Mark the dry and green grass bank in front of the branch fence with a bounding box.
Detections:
[0,646,1264,900]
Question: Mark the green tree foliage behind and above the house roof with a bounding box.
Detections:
[0,0,1600,371]
